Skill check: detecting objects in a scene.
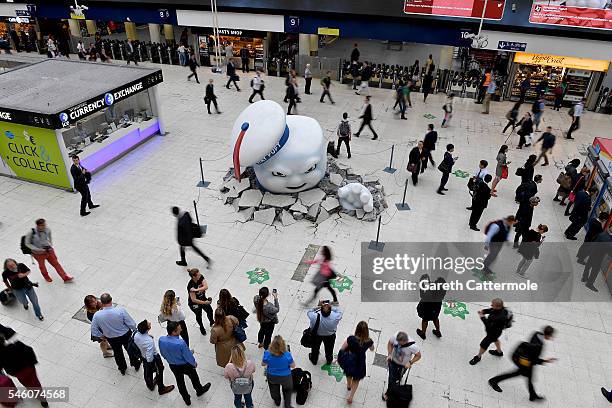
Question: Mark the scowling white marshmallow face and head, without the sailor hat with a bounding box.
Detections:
[253,116,327,193]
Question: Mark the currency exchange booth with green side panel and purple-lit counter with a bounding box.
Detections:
[0,59,164,190]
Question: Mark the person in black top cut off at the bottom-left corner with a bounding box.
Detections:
[0,336,49,408]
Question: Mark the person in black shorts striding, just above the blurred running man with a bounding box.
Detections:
[470,298,512,365]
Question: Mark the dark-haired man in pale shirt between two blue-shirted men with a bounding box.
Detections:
[134,320,174,395]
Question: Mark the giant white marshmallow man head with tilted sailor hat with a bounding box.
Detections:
[232,100,327,193]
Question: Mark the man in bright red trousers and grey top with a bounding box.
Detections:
[25,218,73,283]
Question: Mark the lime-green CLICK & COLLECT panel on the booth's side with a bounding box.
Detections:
[0,121,71,189]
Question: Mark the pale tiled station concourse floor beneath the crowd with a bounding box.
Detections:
[0,57,612,408]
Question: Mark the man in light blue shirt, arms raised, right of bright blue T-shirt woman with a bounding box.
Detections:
[307,300,343,365]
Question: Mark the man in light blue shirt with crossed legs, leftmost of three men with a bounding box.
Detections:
[91,293,141,375]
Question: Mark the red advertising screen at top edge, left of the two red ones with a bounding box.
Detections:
[404,0,505,20]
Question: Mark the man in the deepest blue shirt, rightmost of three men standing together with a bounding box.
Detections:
[158,322,210,405]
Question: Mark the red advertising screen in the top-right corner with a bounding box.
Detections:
[529,0,612,30]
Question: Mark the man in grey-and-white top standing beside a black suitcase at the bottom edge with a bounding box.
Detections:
[383,331,421,401]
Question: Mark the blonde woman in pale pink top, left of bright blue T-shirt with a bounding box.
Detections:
[223,346,255,408]
